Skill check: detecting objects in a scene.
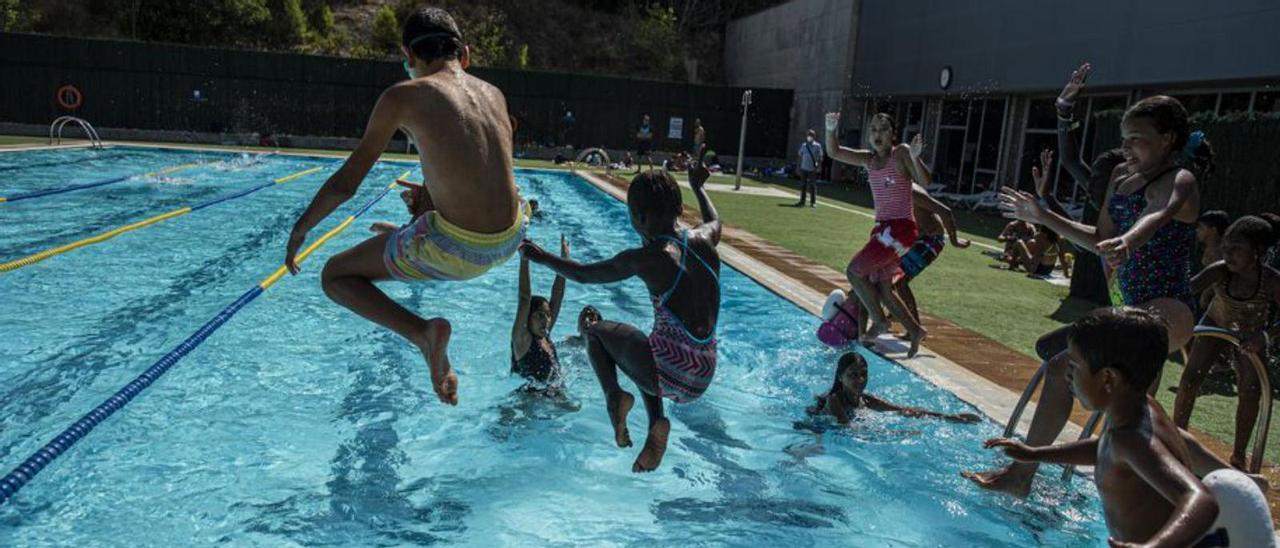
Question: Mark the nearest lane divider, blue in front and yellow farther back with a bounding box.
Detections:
[0,172,410,504]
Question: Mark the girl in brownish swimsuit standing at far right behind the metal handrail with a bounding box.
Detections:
[1174,215,1280,469]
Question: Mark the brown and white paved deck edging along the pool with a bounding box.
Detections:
[12,141,1280,525]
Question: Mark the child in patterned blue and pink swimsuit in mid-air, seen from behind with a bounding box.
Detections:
[521,161,721,472]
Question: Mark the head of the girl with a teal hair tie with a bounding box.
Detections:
[1120,95,1213,177]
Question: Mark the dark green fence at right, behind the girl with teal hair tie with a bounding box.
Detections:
[1094,111,1280,218]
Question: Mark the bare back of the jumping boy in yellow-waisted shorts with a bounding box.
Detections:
[399,68,520,233]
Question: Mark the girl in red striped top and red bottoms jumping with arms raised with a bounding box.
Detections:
[826,113,929,357]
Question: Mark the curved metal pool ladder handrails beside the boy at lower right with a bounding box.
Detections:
[1004,325,1271,481]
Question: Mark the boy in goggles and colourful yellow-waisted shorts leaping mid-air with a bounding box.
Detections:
[284,8,526,405]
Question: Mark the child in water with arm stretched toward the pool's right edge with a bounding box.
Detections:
[805,352,982,424]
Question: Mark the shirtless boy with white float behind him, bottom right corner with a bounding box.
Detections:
[986,307,1275,547]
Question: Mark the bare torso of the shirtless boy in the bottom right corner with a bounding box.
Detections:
[1094,398,1190,542]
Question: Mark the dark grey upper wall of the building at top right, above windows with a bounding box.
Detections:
[852,0,1280,96]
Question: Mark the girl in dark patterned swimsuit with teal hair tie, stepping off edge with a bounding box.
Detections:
[965,89,1213,496]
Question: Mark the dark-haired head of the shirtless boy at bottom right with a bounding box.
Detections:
[1068,306,1169,410]
